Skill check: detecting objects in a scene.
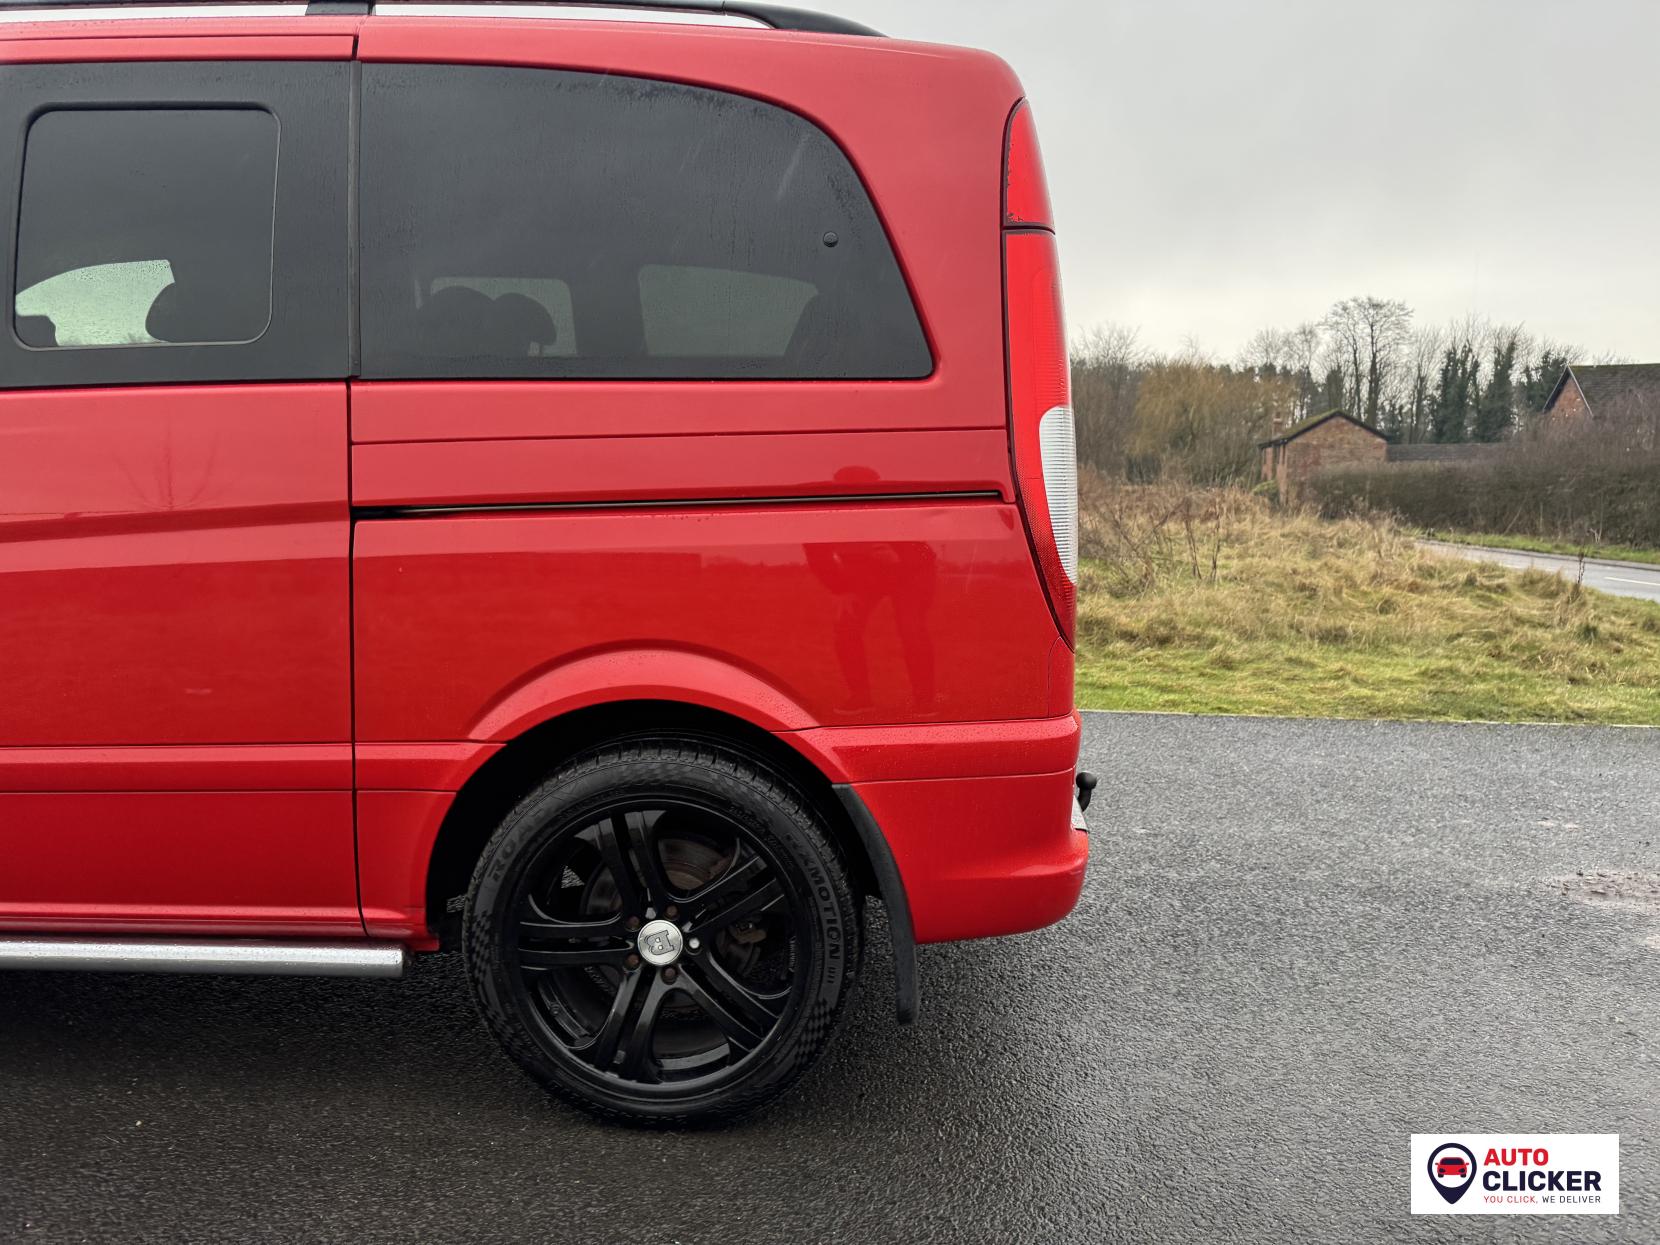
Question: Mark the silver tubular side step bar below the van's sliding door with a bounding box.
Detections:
[0,935,408,978]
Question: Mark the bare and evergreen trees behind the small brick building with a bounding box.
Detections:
[1072,295,1615,483]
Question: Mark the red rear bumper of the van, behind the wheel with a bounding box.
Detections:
[803,714,1089,943]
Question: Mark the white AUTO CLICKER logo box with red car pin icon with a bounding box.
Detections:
[1413,1132,1620,1215]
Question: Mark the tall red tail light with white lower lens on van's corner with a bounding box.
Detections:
[1003,105,1077,644]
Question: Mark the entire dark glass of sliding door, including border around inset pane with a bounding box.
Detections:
[0,61,352,388]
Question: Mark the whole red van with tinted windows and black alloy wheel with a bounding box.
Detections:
[0,0,1092,1122]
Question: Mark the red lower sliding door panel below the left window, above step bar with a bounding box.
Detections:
[0,383,360,933]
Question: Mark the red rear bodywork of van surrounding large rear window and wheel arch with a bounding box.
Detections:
[352,17,1081,940]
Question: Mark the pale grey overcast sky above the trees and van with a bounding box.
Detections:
[843,0,1660,362]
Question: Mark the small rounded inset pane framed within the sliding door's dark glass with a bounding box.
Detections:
[13,108,277,349]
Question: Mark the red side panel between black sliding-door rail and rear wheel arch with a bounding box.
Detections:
[355,501,1054,740]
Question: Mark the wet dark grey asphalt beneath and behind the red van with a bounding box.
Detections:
[0,714,1660,1245]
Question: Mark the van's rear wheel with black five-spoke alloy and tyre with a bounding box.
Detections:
[461,739,863,1125]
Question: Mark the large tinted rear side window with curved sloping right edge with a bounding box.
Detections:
[360,65,933,378]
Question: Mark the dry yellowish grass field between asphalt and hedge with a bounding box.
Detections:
[1077,478,1660,724]
